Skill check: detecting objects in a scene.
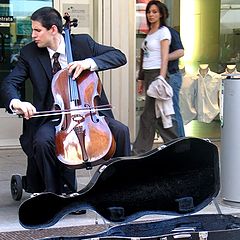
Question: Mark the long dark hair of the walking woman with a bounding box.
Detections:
[145,0,168,29]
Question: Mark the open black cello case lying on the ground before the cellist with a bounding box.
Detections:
[19,137,240,240]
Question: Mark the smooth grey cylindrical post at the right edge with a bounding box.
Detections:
[220,76,240,206]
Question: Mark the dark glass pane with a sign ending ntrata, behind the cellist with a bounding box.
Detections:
[0,0,53,108]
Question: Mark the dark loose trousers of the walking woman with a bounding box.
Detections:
[132,69,178,154]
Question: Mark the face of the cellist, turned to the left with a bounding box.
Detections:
[32,21,53,48]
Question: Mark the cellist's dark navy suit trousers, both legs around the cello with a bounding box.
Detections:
[25,118,130,194]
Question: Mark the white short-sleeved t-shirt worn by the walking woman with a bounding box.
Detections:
[142,26,171,69]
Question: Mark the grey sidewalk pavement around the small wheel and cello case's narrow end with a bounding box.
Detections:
[0,148,103,232]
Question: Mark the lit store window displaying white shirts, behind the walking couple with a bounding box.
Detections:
[136,0,240,139]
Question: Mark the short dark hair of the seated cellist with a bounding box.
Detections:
[31,7,63,33]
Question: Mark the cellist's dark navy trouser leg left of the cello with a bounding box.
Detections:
[26,121,77,194]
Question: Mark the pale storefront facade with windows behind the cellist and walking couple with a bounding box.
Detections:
[0,0,240,147]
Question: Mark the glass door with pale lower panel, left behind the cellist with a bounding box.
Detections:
[0,0,53,148]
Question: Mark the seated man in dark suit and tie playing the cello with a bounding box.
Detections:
[1,7,130,194]
